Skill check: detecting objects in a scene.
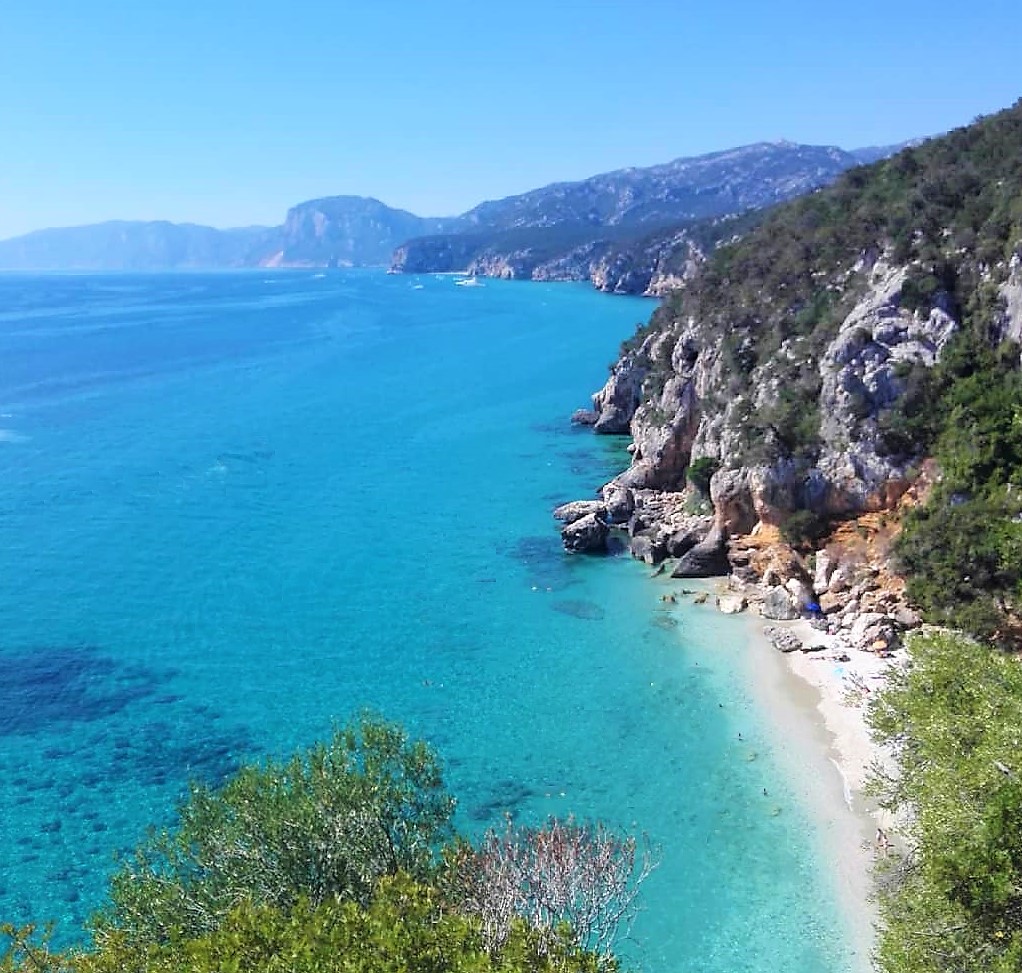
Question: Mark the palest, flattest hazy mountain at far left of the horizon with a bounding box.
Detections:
[0,221,273,271]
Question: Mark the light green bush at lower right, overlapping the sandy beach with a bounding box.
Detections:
[870,634,1022,973]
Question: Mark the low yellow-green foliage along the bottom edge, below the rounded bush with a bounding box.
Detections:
[0,873,614,973]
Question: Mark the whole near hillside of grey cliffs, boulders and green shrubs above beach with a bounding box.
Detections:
[562,101,1022,649]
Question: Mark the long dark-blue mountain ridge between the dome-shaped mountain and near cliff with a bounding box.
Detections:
[392,142,911,293]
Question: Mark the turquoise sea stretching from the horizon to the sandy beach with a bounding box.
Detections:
[0,271,850,973]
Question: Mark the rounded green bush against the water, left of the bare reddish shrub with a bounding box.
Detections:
[98,717,454,942]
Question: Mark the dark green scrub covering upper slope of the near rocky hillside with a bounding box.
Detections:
[647,102,1022,464]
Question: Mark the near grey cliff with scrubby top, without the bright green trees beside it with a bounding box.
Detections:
[565,103,1022,637]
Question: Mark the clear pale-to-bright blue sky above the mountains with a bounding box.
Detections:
[0,0,1022,237]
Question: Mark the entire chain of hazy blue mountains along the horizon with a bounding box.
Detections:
[0,142,915,284]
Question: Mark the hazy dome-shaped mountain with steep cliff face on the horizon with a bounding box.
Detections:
[259,196,457,267]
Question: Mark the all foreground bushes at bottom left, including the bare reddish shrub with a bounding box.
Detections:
[0,717,655,973]
